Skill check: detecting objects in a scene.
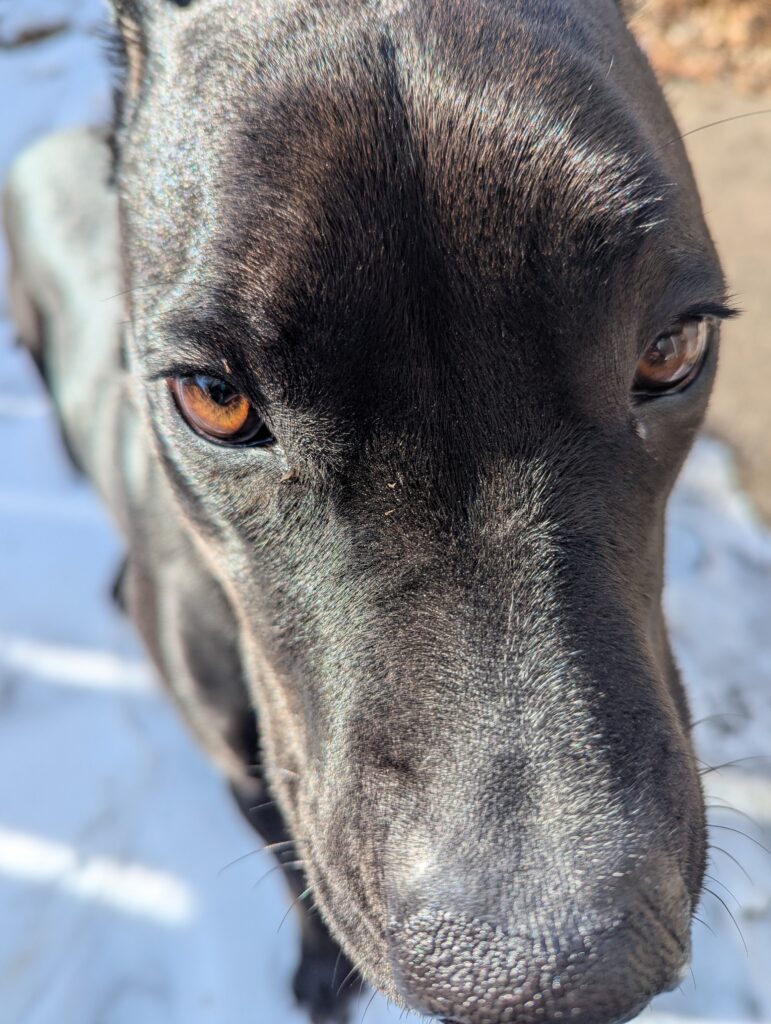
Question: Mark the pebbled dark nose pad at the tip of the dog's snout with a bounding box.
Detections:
[391,908,682,1024]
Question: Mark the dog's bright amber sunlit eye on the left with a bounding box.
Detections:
[168,374,273,445]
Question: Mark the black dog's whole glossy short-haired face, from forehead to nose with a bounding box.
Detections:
[111,0,728,1024]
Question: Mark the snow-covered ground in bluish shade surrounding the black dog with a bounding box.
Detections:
[0,0,771,1024]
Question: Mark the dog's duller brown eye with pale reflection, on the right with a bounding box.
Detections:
[634,316,718,395]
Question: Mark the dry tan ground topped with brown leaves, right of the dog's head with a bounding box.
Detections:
[630,0,771,521]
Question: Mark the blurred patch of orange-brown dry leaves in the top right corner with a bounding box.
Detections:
[626,0,771,93]
